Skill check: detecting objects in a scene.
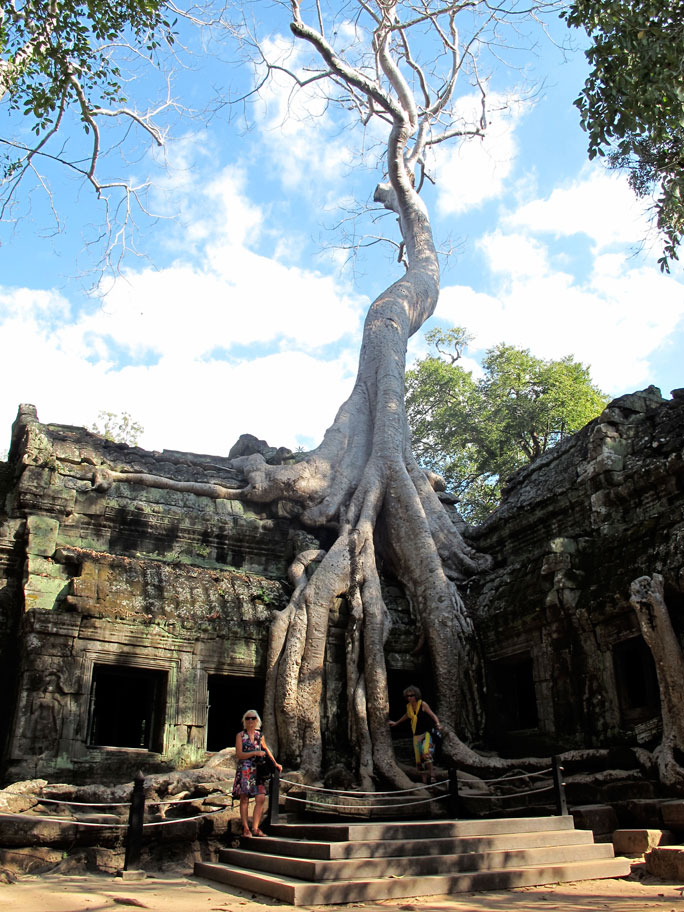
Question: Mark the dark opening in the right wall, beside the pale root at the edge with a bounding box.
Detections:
[613,636,660,724]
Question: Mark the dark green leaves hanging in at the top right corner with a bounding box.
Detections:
[563,0,684,272]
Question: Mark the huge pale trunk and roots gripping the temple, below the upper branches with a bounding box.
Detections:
[206,173,500,785]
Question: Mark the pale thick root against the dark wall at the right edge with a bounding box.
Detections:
[630,573,684,793]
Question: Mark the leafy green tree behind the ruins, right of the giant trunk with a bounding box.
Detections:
[406,327,608,522]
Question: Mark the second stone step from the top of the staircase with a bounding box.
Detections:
[241,829,593,861]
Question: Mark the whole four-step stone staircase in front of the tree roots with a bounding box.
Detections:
[195,816,630,906]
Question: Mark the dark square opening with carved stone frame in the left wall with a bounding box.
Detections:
[88,665,168,753]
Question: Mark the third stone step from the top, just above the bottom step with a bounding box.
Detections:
[219,843,614,883]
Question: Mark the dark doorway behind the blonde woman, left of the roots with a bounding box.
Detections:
[207,674,264,751]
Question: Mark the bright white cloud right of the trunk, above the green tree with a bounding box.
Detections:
[436,232,684,394]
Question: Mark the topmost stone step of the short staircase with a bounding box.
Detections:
[269,815,574,842]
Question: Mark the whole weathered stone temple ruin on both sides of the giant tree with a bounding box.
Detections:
[0,387,684,797]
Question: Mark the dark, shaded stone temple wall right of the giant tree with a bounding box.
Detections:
[467,387,684,753]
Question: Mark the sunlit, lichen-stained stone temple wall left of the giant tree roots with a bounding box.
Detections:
[0,407,292,778]
